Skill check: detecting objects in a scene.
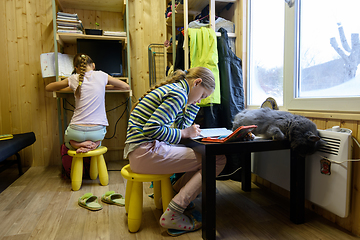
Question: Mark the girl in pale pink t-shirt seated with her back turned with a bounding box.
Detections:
[45,53,130,153]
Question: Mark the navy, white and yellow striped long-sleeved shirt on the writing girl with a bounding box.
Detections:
[124,80,200,158]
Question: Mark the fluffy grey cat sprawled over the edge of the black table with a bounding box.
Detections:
[233,108,324,155]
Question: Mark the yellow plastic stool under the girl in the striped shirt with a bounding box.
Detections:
[121,164,174,232]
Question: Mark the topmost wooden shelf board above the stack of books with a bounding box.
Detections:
[56,0,126,13]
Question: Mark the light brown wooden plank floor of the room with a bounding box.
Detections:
[0,161,359,240]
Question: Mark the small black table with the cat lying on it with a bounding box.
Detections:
[185,140,305,239]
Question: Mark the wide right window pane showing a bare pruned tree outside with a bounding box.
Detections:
[296,0,360,98]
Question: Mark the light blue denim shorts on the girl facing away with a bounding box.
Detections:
[64,124,106,150]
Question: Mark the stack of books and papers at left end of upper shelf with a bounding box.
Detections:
[56,12,84,34]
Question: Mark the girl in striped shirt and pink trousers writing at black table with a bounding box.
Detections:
[124,67,226,236]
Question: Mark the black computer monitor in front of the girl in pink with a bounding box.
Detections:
[77,39,123,77]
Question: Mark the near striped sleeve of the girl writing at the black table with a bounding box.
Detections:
[143,90,187,144]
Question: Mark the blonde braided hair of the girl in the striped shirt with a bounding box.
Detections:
[132,67,215,110]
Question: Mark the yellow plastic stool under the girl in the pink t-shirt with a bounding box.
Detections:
[68,146,109,191]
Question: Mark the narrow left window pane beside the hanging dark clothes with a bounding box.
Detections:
[247,0,284,105]
